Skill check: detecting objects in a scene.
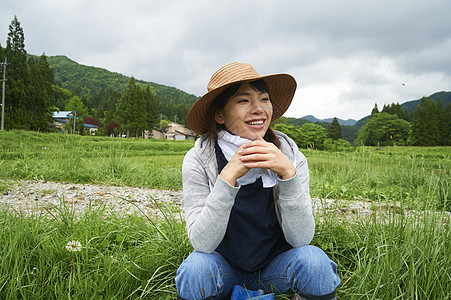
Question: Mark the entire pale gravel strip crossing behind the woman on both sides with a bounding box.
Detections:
[0,180,450,222]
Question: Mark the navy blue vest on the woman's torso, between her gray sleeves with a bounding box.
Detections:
[215,143,292,272]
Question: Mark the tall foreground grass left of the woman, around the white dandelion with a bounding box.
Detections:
[0,201,191,299]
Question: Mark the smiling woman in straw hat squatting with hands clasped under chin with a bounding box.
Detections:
[175,63,340,300]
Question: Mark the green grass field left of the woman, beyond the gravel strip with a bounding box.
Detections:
[0,131,193,189]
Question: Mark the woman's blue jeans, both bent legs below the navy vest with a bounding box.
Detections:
[175,246,340,300]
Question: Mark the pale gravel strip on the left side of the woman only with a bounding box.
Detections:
[0,180,183,216]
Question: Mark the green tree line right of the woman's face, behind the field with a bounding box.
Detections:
[273,97,451,150]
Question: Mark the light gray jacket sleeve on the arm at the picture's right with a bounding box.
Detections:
[277,145,315,247]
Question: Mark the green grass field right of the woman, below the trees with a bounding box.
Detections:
[305,147,451,211]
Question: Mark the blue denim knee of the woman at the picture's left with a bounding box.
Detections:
[175,251,228,299]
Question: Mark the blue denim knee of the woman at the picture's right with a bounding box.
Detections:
[288,245,340,296]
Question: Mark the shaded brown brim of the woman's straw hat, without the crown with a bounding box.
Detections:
[186,74,297,134]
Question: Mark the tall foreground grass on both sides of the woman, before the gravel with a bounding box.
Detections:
[0,199,451,299]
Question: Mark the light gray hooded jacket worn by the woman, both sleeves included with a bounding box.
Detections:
[182,131,315,253]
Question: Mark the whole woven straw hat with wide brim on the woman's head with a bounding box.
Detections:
[186,62,296,134]
